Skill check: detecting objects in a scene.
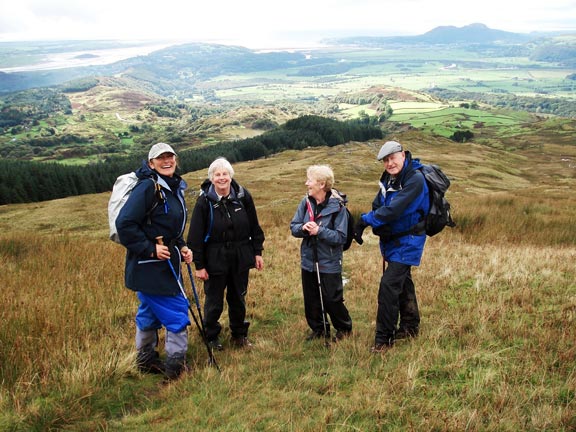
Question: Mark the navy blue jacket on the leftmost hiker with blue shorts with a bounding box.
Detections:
[116,161,187,295]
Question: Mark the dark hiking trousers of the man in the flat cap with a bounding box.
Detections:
[375,262,420,345]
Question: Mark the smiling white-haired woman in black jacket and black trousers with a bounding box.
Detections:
[187,158,264,351]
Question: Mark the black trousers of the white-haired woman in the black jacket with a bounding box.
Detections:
[204,270,249,340]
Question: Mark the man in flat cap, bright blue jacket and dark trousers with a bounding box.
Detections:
[354,141,429,353]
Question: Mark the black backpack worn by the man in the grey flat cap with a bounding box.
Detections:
[419,164,456,237]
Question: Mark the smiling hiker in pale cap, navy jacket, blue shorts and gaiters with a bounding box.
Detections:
[116,143,192,379]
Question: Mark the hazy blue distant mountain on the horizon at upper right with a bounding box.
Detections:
[327,23,541,45]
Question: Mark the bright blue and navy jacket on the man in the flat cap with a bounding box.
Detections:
[361,151,430,266]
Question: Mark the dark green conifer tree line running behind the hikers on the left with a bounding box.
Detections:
[0,115,383,205]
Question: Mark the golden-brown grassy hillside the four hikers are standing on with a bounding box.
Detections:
[0,131,576,431]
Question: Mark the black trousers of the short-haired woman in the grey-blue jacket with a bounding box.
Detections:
[302,270,352,334]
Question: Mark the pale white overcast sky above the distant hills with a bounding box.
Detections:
[0,0,576,48]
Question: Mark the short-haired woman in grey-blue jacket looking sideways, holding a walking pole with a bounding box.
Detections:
[290,165,352,340]
